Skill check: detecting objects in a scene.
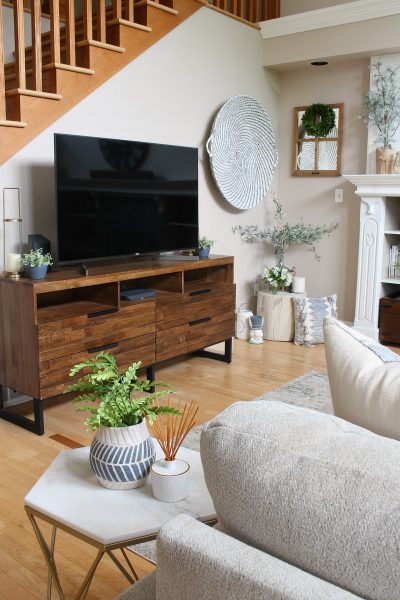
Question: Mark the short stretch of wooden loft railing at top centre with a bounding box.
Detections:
[200,0,280,23]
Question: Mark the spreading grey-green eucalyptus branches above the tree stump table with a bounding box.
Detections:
[232,198,339,265]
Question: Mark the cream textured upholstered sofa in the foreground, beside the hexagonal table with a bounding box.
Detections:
[120,401,400,600]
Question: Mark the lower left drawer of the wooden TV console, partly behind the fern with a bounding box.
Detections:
[40,333,155,398]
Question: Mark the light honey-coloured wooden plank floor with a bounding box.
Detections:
[0,340,326,600]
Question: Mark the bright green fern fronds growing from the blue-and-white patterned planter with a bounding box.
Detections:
[64,352,181,431]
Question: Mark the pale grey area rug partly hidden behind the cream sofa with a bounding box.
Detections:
[130,371,333,564]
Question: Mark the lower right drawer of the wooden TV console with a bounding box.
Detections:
[156,312,235,362]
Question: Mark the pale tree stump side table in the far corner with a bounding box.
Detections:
[257,292,305,342]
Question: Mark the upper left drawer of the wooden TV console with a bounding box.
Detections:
[38,302,155,361]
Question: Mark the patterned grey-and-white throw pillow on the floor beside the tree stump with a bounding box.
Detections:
[293,294,337,346]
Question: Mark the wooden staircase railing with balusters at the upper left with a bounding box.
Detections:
[0,0,153,124]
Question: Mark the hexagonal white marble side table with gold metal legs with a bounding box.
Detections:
[25,441,216,600]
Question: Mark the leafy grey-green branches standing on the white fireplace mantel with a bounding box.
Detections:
[362,62,400,148]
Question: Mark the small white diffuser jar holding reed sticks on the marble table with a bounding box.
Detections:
[151,458,190,502]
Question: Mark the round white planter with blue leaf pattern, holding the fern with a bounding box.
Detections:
[90,419,156,490]
